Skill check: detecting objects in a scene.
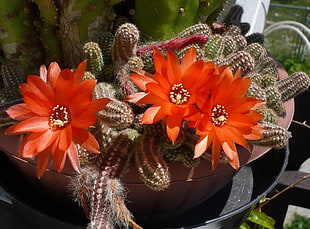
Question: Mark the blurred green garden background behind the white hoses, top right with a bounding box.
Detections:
[265,0,310,74]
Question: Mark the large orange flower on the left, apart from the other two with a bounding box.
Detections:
[6,61,109,178]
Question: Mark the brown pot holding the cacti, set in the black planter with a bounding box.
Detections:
[0,65,294,217]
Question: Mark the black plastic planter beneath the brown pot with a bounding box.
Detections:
[0,144,289,229]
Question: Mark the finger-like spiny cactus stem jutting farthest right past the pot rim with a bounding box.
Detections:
[276,72,310,102]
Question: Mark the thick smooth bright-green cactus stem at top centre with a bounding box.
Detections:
[133,0,199,40]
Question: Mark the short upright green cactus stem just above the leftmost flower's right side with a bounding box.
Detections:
[83,41,104,80]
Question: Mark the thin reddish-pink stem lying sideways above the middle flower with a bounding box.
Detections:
[136,34,209,57]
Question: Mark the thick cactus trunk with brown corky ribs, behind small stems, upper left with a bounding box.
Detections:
[58,0,113,68]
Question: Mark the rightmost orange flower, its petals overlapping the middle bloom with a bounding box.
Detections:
[190,68,263,169]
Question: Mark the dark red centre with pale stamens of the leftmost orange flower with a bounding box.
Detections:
[49,105,71,131]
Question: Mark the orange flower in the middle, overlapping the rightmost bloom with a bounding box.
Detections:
[125,48,219,143]
